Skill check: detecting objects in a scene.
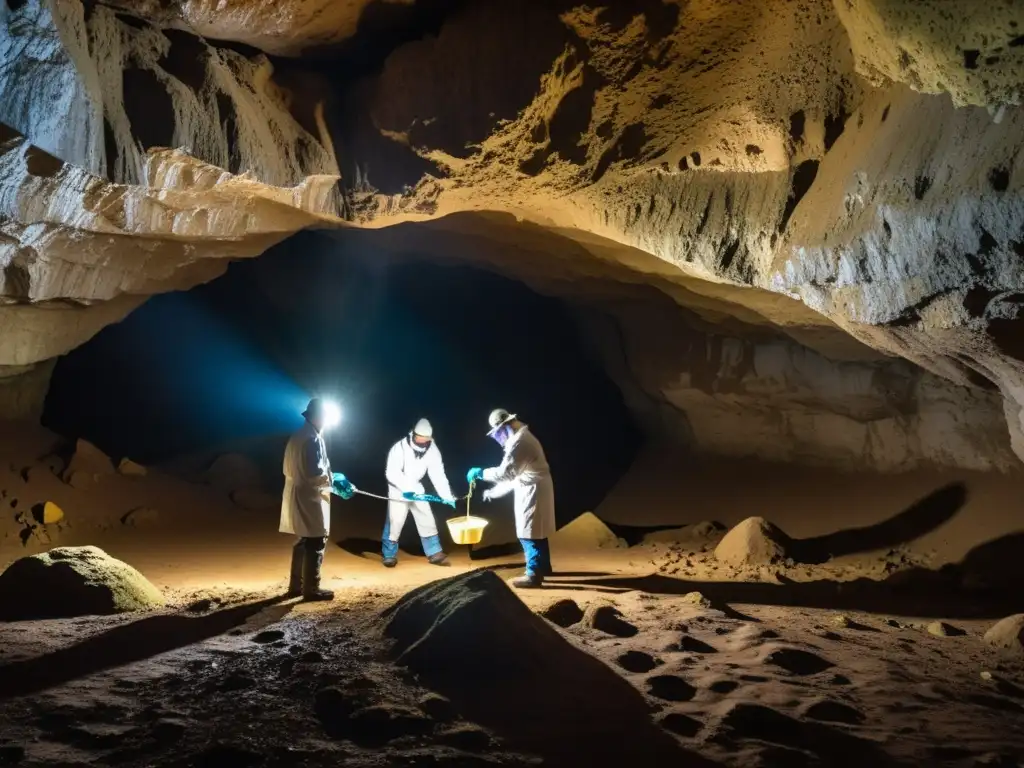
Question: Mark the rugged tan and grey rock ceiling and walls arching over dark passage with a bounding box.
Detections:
[0,0,1024,470]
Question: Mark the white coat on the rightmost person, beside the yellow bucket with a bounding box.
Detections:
[483,425,555,539]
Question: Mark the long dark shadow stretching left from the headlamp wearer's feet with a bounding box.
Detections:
[0,596,286,699]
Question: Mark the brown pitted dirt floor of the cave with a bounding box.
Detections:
[0,430,1024,768]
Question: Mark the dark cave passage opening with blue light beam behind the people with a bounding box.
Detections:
[43,233,641,523]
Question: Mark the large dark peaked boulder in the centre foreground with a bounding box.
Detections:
[384,569,708,766]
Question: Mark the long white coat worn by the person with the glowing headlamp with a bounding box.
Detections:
[281,422,331,538]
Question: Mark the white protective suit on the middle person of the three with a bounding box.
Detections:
[386,437,452,542]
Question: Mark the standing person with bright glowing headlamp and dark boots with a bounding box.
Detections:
[281,397,353,600]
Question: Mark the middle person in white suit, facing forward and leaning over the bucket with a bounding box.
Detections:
[381,419,455,568]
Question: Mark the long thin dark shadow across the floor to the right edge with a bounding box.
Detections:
[545,568,1020,620]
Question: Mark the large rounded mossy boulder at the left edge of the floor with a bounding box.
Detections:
[0,547,165,622]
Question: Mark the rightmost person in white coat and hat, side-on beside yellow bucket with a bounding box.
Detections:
[466,408,555,588]
